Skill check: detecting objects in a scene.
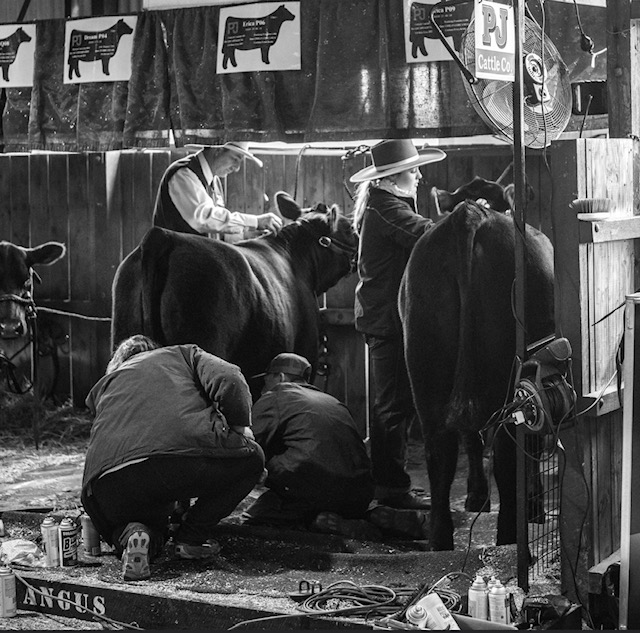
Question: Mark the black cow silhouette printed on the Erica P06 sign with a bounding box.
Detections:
[222,4,295,69]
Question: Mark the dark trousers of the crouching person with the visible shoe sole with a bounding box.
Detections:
[82,445,264,553]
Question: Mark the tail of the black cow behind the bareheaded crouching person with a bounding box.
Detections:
[140,227,173,345]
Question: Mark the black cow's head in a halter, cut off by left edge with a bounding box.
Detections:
[0,241,65,339]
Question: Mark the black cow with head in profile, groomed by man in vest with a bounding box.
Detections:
[112,192,357,395]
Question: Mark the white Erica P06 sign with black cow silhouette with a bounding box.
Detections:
[216,2,301,74]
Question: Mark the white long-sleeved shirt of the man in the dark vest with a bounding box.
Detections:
[169,152,258,233]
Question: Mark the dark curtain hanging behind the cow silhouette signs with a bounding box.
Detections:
[0,0,606,151]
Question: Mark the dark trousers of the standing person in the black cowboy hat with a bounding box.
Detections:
[365,334,415,499]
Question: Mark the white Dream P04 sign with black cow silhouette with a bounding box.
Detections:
[64,15,137,84]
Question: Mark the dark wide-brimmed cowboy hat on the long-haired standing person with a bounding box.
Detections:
[349,139,447,182]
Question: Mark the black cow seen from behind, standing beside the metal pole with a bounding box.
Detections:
[398,200,554,550]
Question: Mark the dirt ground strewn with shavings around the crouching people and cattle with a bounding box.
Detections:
[0,402,558,630]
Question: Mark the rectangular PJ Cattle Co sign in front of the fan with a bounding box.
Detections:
[475,0,516,81]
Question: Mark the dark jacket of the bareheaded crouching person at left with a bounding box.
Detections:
[83,345,260,488]
